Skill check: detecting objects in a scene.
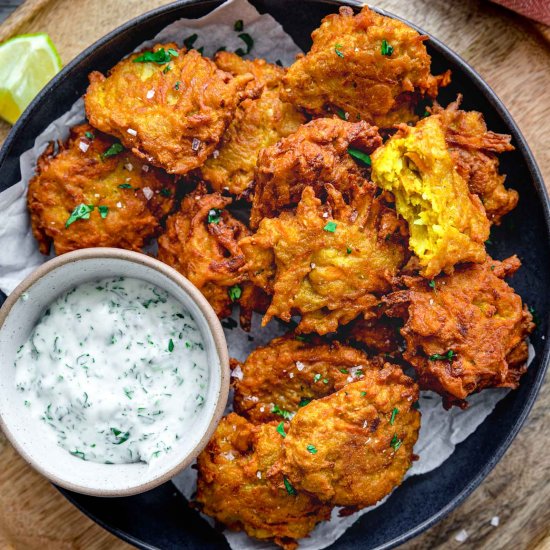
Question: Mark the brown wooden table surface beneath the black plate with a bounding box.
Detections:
[0,0,550,550]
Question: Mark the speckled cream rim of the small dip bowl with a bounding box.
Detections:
[0,247,230,497]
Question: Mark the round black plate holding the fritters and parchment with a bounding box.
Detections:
[0,0,550,550]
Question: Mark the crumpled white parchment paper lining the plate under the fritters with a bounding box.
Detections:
[0,0,533,550]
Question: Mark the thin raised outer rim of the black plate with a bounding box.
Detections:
[0,0,550,550]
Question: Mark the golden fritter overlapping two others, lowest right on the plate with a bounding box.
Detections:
[281,363,420,512]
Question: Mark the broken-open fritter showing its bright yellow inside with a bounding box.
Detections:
[372,117,490,278]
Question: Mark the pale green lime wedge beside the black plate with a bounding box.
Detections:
[0,33,61,124]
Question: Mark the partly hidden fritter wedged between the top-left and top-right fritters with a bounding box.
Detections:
[201,52,306,195]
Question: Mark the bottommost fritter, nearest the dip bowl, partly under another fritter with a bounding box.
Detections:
[196,413,331,550]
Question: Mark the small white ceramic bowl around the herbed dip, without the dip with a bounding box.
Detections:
[0,248,229,496]
